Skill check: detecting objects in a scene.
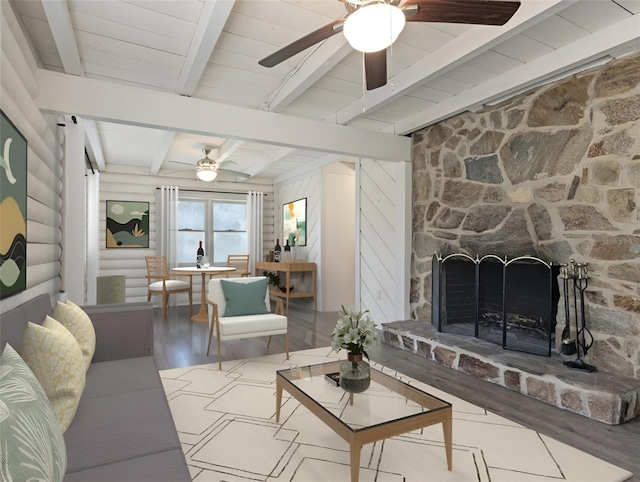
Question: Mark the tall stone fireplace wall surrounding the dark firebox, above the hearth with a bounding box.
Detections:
[410,55,640,379]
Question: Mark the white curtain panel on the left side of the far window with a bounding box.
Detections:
[156,186,179,268]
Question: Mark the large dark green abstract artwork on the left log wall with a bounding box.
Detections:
[0,111,27,299]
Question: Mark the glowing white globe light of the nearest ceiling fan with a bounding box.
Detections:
[344,1,405,53]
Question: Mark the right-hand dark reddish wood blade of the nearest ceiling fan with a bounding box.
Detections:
[402,0,520,25]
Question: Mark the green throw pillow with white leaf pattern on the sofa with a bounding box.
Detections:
[0,343,67,482]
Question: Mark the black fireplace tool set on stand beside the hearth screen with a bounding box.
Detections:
[560,260,597,372]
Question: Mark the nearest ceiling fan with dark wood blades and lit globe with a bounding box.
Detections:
[258,0,520,90]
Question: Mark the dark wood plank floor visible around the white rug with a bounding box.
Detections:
[154,303,640,482]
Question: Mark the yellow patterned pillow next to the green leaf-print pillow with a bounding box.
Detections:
[20,316,86,432]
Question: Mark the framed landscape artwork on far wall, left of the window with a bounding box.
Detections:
[107,201,149,248]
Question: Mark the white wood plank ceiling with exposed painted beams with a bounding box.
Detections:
[10,0,640,182]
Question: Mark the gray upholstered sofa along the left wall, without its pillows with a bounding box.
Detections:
[0,295,191,482]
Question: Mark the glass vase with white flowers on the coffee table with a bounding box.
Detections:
[331,305,378,393]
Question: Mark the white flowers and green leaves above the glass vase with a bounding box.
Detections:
[331,305,378,359]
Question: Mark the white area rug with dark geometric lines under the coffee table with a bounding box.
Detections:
[160,348,633,482]
